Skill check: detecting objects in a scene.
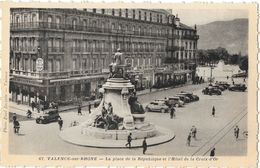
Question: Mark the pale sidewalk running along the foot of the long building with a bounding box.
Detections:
[9,83,199,117]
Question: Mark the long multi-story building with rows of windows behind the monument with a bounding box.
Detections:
[10,8,197,102]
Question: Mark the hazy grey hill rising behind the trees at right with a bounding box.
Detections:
[197,19,248,55]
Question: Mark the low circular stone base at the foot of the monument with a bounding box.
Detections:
[60,125,175,148]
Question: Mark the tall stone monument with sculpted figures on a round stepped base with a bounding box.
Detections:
[60,49,174,147]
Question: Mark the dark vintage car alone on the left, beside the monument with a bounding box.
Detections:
[36,109,60,124]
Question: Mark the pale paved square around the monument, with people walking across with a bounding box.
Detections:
[9,78,247,156]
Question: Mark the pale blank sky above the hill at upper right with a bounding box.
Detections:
[172,9,248,26]
